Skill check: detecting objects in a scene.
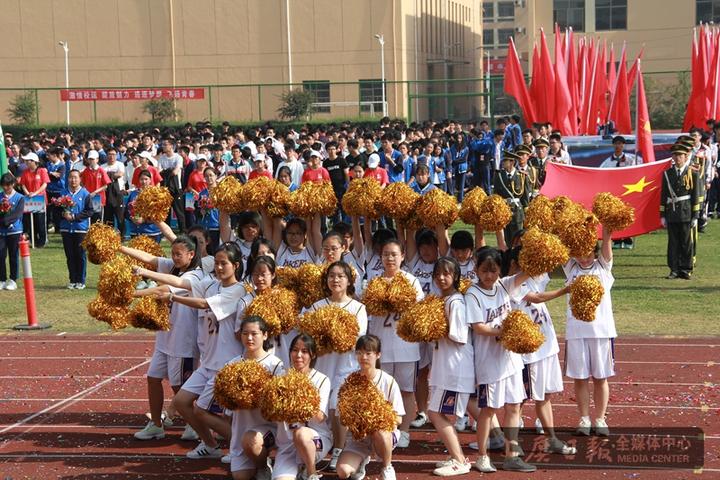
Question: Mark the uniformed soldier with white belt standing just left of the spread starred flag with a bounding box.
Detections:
[493,150,531,245]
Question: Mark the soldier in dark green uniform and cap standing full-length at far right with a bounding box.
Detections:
[660,143,700,280]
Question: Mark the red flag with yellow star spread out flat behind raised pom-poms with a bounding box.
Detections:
[540,159,670,239]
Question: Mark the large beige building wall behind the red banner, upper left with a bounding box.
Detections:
[0,0,482,123]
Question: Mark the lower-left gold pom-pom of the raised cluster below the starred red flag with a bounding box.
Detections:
[518,227,569,277]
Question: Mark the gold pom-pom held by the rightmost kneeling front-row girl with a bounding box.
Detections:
[337,372,397,440]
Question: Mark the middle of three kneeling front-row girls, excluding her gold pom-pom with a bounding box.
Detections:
[273,333,332,480]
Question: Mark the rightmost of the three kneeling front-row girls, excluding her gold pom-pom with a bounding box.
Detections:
[337,335,405,480]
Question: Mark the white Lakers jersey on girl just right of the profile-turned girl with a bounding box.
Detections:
[465,276,523,385]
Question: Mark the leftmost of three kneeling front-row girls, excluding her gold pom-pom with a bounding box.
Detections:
[228,315,284,480]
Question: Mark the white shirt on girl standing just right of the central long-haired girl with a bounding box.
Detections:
[368,270,425,363]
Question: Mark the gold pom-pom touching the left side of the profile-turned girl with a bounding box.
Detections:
[397,295,448,342]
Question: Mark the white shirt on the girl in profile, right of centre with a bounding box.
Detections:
[429,292,476,393]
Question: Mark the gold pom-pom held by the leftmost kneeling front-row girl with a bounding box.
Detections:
[213,360,272,410]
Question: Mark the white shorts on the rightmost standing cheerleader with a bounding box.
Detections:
[565,338,615,380]
